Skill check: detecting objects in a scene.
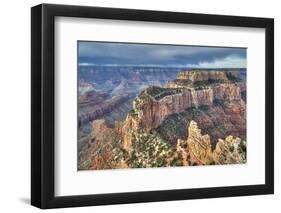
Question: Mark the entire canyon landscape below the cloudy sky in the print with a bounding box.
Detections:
[78,65,247,170]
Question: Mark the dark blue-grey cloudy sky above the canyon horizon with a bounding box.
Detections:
[78,41,246,68]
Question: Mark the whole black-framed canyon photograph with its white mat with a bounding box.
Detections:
[31,4,274,208]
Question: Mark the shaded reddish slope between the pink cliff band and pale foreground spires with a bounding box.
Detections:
[156,97,246,148]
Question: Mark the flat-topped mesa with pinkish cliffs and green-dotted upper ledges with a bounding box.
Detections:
[127,71,242,129]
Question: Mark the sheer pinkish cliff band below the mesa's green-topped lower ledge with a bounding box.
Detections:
[134,84,241,128]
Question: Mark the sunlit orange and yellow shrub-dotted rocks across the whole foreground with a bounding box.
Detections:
[79,111,246,170]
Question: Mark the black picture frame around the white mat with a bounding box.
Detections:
[31,4,274,209]
